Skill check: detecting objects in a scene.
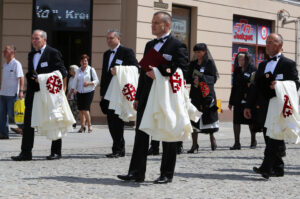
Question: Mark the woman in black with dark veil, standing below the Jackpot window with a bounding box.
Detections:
[228,52,257,150]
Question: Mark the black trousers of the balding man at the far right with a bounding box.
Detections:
[260,137,286,174]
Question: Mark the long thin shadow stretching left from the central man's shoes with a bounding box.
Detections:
[23,176,153,187]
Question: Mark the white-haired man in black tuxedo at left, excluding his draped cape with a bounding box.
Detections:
[11,30,67,161]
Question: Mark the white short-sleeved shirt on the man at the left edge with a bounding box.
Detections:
[0,58,24,96]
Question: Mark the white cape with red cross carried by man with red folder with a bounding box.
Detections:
[139,68,201,142]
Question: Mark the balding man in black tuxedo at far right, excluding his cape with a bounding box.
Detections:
[244,33,299,179]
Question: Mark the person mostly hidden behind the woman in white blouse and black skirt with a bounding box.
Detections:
[68,65,79,128]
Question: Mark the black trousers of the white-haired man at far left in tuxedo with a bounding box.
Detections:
[21,93,62,155]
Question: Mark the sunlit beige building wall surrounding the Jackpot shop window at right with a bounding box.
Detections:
[136,0,300,119]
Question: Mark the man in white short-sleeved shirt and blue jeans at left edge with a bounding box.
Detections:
[0,45,24,139]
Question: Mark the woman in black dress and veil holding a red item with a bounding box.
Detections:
[187,43,219,153]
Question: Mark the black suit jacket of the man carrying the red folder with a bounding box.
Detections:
[135,35,189,111]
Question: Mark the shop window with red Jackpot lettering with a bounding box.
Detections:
[232,15,272,71]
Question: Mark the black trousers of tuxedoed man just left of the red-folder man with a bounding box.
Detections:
[107,109,125,154]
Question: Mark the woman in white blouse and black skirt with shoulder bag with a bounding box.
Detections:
[70,54,99,133]
